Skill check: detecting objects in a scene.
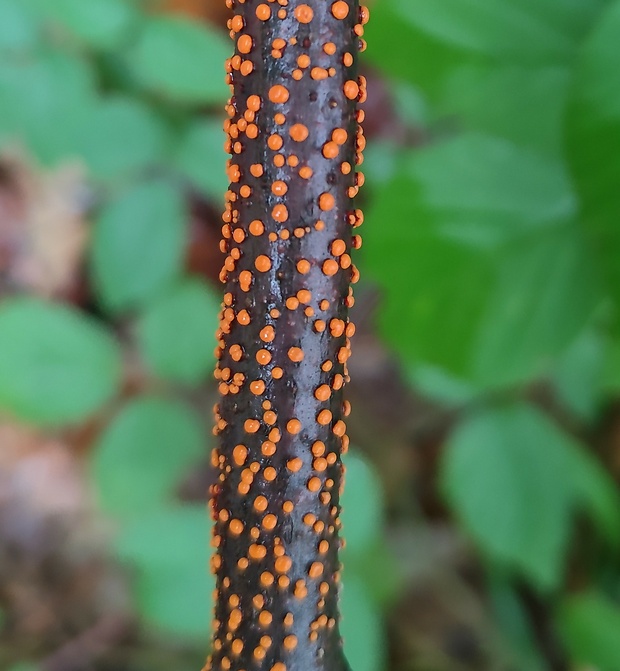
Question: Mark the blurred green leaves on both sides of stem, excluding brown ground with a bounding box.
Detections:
[0,0,620,671]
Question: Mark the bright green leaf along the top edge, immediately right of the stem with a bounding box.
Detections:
[367,0,606,96]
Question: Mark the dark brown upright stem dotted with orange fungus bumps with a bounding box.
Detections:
[208,0,367,671]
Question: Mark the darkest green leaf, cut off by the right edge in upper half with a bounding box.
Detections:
[567,1,620,316]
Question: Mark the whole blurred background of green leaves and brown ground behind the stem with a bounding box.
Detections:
[0,0,620,671]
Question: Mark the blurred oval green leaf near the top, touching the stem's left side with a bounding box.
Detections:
[129,16,230,104]
